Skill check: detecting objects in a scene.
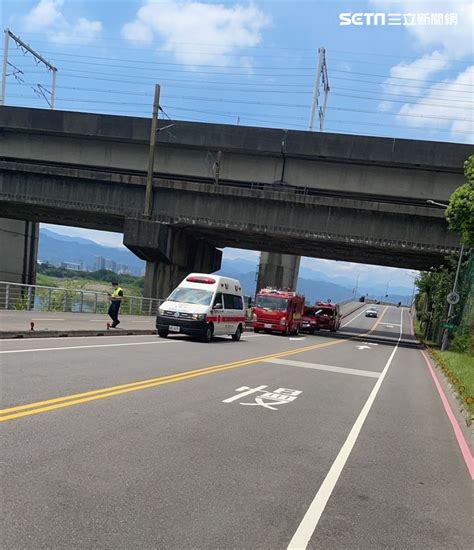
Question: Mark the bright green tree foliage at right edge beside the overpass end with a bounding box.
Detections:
[446,155,474,247]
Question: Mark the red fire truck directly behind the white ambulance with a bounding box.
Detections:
[252,288,304,336]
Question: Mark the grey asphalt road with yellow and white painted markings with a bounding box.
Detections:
[0,307,473,549]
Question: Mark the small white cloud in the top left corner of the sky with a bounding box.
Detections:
[23,0,102,44]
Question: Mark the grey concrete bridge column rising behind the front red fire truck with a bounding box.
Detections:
[257,252,301,292]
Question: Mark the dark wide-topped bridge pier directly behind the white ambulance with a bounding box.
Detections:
[123,219,222,298]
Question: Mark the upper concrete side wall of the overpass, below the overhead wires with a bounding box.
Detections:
[0,107,471,205]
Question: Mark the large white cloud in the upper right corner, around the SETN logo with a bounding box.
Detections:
[371,0,474,143]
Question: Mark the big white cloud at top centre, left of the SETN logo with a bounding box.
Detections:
[122,0,270,66]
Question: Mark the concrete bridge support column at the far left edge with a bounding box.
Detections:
[0,218,39,285]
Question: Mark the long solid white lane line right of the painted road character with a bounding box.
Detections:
[288,310,403,550]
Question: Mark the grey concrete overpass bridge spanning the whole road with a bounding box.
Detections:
[0,107,471,296]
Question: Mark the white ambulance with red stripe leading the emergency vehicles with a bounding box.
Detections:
[156,273,245,342]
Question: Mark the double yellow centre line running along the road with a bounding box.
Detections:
[0,306,388,422]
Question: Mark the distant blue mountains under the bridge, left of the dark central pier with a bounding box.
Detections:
[38,228,144,275]
